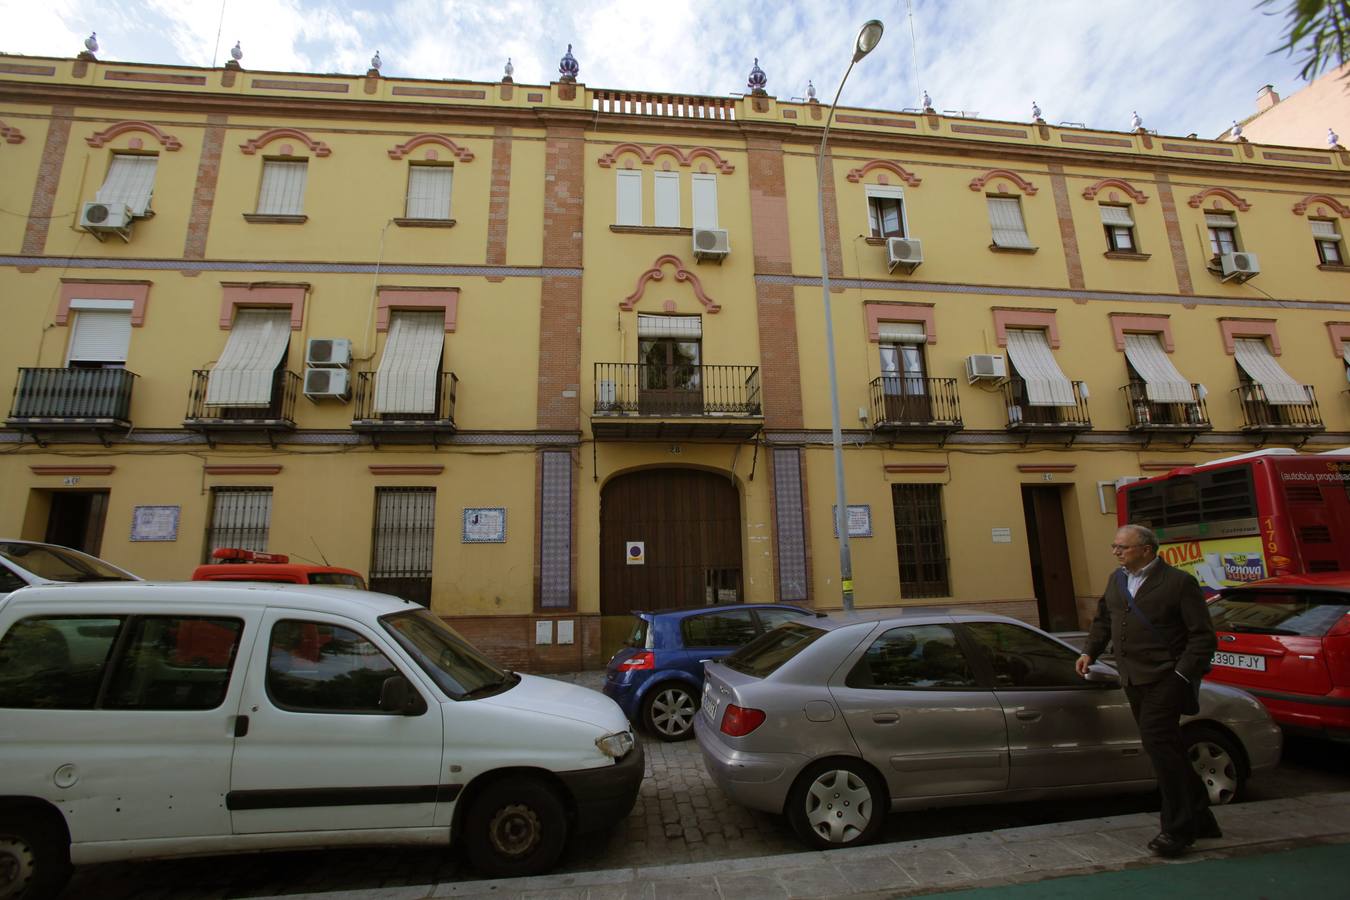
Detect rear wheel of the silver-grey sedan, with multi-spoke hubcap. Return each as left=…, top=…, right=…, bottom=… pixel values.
left=787, top=761, right=890, bottom=850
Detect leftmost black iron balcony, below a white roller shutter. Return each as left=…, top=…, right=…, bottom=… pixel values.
left=5, top=368, right=136, bottom=447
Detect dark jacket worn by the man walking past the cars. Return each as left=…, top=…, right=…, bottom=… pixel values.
left=1083, top=560, right=1218, bottom=684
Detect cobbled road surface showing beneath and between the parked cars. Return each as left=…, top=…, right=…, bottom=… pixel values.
left=63, top=737, right=1350, bottom=900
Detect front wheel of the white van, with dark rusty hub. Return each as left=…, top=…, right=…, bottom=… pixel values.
left=464, top=777, right=567, bottom=877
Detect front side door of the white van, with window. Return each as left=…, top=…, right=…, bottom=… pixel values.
left=227, top=609, right=443, bottom=834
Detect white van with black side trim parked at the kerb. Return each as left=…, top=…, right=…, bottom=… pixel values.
left=0, top=582, right=643, bottom=900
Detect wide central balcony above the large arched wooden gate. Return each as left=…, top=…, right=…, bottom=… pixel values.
left=591, top=363, right=764, bottom=441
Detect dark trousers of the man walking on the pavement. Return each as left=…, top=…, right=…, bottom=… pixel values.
left=1125, top=675, right=1214, bottom=841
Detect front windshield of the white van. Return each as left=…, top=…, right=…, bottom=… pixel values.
left=379, top=610, right=520, bottom=700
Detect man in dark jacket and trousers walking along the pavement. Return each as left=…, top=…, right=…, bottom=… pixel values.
left=1077, top=525, right=1223, bottom=857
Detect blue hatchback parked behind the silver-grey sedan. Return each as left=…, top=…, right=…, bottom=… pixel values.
left=605, top=603, right=819, bottom=741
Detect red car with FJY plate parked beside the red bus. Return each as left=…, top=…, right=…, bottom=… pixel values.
left=1206, top=572, right=1350, bottom=741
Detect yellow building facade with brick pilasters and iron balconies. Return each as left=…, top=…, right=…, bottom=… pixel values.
left=0, top=50, right=1350, bottom=669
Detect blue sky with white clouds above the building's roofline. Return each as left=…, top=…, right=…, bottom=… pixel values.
left=0, top=0, right=1328, bottom=138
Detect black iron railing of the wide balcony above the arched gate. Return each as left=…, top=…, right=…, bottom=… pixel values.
left=595, top=363, right=763, bottom=418
